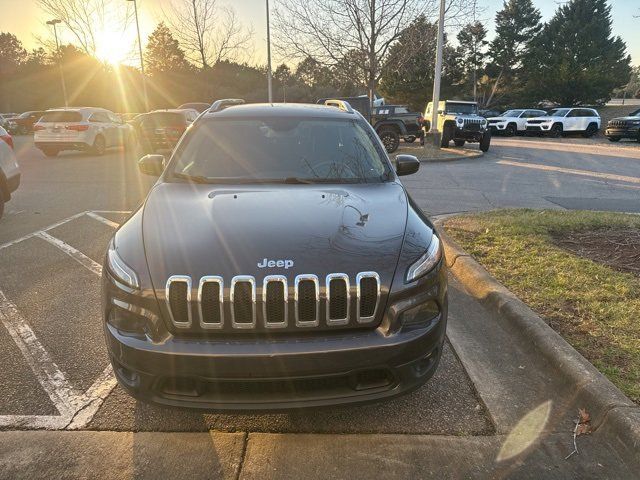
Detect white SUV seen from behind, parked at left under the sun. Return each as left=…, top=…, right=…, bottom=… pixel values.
left=33, top=107, right=134, bottom=157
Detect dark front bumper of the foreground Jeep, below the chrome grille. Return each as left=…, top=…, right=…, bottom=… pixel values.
left=103, top=267, right=447, bottom=411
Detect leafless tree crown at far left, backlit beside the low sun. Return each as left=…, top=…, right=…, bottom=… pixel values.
left=37, top=0, right=133, bottom=55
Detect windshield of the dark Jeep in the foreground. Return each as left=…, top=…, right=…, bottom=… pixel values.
left=173, top=118, right=389, bottom=183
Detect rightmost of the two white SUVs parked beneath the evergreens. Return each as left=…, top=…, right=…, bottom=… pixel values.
left=527, top=108, right=601, bottom=137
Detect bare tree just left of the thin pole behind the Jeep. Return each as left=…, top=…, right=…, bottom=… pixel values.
left=165, top=0, right=253, bottom=68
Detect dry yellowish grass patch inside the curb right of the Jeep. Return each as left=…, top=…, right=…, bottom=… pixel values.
left=445, top=210, right=640, bottom=404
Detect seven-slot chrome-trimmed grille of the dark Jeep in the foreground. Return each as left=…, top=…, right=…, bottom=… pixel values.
left=165, top=272, right=381, bottom=333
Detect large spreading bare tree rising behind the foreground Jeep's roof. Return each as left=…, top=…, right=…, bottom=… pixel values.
left=274, top=0, right=470, bottom=105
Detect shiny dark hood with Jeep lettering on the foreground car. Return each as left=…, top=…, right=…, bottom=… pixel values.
left=142, top=182, right=407, bottom=289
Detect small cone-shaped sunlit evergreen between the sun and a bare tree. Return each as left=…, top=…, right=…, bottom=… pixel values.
left=144, top=22, right=190, bottom=76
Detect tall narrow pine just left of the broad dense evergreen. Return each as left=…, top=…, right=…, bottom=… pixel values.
left=487, top=0, right=542, bottom=105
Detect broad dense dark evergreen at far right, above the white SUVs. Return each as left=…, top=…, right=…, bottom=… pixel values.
left=528, top=0, right=631, bottom=106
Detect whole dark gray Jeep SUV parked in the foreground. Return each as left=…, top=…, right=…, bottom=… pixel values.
left=102, top=101, right=447, bottom=411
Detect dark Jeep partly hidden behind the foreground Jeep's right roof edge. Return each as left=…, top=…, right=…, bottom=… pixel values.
left=318, top=97, right=424, bottom=153
